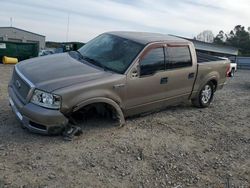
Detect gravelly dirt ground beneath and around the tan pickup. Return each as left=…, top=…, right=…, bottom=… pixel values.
left=0, top=65, right=250, bottom=188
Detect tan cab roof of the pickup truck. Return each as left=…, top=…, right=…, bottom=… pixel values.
left=107, top=31, right=190, bottom=45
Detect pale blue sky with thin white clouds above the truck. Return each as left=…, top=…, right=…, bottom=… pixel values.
left=0, top=0, right=250, bottom=42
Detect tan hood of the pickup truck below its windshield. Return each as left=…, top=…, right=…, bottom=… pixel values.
left=16, top=53, right=112, bottom=92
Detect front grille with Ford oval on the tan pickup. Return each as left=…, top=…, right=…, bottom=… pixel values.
left=12, top=69, right=30, bottom=100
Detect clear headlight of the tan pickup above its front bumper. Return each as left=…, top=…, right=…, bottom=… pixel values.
left=30, top=89, right=61, bottom=109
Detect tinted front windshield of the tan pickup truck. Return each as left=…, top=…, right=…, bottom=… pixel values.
left=78, top=34, right=143, bottom=74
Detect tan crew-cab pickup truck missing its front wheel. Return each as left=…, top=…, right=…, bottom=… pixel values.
left=8, top=32, right=230, bottom=134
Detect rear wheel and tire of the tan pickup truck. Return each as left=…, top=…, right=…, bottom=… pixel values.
left=192, top=82, right=215, bottom=108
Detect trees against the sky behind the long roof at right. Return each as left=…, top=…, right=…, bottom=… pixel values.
left=213, top=25, right=250, bottom=56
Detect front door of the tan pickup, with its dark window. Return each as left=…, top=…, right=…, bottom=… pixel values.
left=126, top=44, right=168, bottom=109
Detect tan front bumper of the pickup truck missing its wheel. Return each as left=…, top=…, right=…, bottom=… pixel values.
left=8, top=86, right=68, bottom=135
